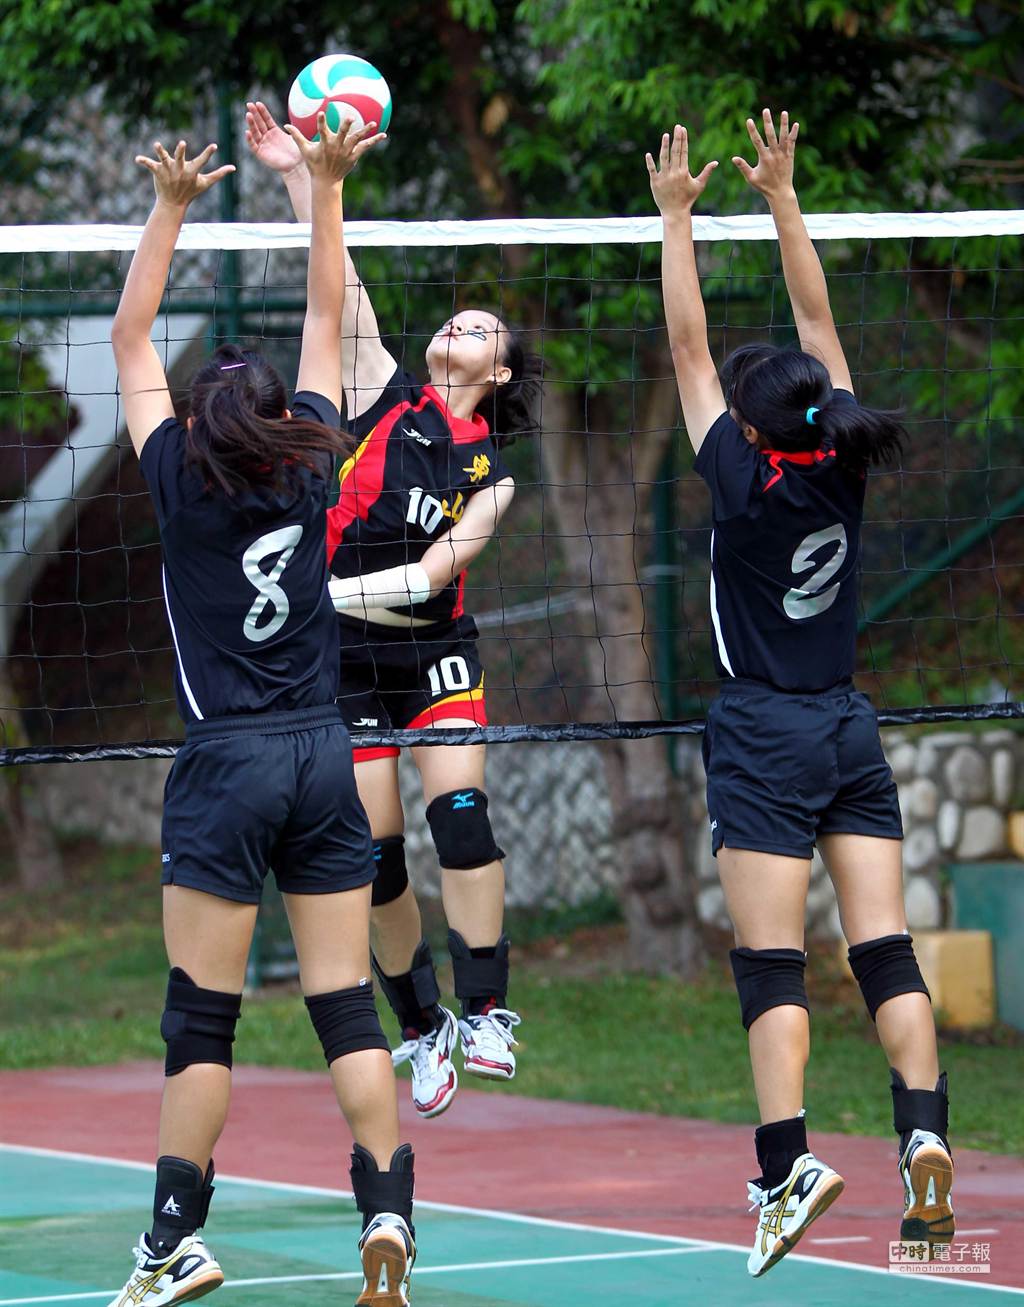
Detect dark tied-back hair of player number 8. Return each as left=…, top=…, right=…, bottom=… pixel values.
left=186, top=345, right=352, bottom=494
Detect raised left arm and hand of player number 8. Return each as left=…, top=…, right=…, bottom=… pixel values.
left=110, top=141, right=234, bottom=454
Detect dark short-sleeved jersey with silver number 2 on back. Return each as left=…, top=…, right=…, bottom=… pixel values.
left=696, top=391, right=866, bottom=693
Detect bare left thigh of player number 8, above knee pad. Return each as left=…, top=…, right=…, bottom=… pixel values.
left=163, top=885, right=258, bottom=993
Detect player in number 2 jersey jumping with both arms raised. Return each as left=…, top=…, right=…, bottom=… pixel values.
left=647, top=110, right=953, bottom=1276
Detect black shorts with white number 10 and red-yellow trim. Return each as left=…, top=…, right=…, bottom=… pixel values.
left=337, top=616, right=486, bottom=762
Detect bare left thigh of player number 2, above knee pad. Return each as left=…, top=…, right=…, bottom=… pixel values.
left=718, top=848, right=811, bottom=949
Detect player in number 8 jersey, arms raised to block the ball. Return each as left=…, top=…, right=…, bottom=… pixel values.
left=111, top=118, right=415, bottom=1307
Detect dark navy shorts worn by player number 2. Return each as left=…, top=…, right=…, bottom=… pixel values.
left=704, top=680, right=904, bottom=857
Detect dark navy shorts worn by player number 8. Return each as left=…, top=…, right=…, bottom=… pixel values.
left=161, top=706, right=375, bottom=903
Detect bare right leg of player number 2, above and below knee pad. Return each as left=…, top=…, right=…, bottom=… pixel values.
left=820, top=835, right=939, bottom=1089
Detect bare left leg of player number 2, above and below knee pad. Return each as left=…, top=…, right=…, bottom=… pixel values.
left=717, top=848, right=811, bottom=1123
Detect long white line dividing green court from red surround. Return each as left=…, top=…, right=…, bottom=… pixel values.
left=0, top=1144, right=1024, bottom=1307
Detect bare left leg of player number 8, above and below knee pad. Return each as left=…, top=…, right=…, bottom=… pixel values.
left=158, top=885, right=256, bottom=1171
